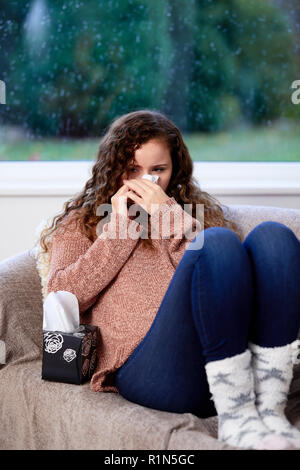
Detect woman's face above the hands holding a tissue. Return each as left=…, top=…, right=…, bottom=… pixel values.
left=122, top=139, right=172, bottom=192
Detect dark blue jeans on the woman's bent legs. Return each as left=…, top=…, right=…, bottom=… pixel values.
left=115, top=221, right=300, bottom=418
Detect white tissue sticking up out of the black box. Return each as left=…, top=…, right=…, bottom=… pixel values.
left=43, top=290, right=79, bottom=333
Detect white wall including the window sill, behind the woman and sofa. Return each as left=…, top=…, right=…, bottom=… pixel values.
left=0, top=162, right=300, bottom=261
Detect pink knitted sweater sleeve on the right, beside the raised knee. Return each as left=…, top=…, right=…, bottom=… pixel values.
left=151, top=197, right=203, bottom=268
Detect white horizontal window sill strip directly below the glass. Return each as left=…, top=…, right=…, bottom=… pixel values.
left=0, top=160, right=300, bottom=200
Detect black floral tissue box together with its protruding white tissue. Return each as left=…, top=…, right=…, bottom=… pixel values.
left=42, top=291, right=98, bottom=384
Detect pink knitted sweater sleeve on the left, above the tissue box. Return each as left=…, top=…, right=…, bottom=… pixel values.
left=47, top=212, right=141, bottom=313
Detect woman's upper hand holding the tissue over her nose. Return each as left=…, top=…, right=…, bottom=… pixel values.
left=123, top=179, right=169, bottom=215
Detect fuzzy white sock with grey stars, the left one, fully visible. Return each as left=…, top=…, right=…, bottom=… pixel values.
left=205, top=349, right=291, bottom=450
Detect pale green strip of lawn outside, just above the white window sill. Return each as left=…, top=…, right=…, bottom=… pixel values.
left=0, top=123, right=300, bottom=162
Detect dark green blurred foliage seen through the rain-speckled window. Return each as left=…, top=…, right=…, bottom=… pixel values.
left=0, top=0, right=300, bottom=137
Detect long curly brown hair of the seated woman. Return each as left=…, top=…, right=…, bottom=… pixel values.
left=39, top=109, right=240, bottom=253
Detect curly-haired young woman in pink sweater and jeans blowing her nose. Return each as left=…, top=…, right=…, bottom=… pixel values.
left=40, top=110, right=300, bottom=449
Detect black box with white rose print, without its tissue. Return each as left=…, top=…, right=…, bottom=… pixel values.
left=42, top=325, right=98, bottom=385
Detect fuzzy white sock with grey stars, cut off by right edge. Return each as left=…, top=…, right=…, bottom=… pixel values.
left=249, top=340, right=300, bottom=448
